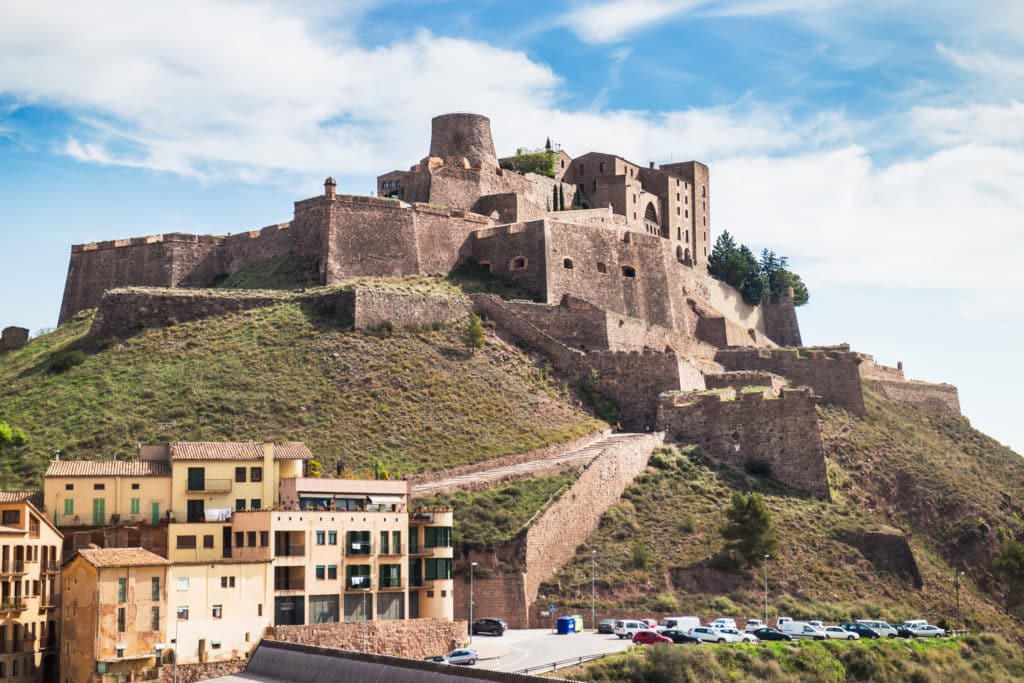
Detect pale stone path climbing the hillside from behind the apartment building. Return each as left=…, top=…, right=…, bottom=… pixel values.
left=413, top=433, right=645, bottom=497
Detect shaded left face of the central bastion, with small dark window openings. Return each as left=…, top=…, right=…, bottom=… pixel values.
left=470, top=220, right=548, bottom=301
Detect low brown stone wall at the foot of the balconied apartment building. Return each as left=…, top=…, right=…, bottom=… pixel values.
left=268, top=618, right=468, bottom=659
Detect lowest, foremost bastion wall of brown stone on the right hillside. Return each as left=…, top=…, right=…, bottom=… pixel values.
left=657, top=389, right=830, bottom=500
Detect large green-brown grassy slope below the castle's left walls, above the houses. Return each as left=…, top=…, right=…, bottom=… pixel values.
left=0, top=282, right=601, bottom=487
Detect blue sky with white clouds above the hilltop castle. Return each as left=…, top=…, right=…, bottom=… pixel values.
left=0, top=0, right=1024, bottom=452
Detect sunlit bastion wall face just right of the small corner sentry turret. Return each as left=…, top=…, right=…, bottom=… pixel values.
left=321, top=196, right=420, bottom=285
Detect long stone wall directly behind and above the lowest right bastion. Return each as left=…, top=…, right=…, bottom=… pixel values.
left=715, top=348, right=864, bottom=415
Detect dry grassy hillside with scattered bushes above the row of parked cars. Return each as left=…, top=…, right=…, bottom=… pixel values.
left=541, top=397, right=1024, bottom=639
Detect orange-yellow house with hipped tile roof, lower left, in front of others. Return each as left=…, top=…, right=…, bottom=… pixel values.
left=60, top=548, right=170, bottom=683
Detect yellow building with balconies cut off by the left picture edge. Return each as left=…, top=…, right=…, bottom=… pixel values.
left=0, top=492, right=62, bottom=681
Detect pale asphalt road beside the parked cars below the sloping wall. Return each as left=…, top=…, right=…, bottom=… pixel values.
left=473, top=629, right=633, bottom=672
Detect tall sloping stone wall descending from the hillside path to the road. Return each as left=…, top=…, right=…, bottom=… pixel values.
left=455, top=433, right=664, bottom=629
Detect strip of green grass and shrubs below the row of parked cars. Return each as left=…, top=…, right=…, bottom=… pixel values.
left=565, top=636, right=1024, bottom=683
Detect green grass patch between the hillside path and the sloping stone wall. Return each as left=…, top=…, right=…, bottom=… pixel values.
left=416, top=469, right=579, bottom=551
